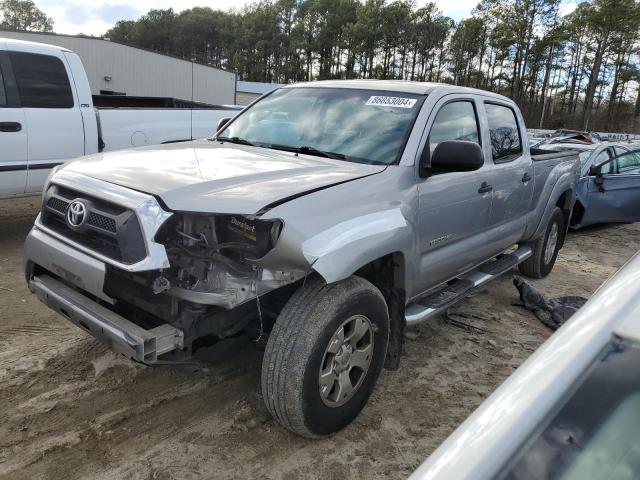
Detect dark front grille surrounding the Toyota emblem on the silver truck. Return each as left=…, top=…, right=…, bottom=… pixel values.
left=41, top=185, right=146, bottom=264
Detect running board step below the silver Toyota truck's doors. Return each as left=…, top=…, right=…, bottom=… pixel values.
left=405, top=246, right=532, bottom=326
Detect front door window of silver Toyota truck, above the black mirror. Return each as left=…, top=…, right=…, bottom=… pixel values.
left=428, top=100, right=480, bottom=158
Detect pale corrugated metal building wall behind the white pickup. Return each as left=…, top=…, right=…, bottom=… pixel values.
left=0, top=31, right=236, bottom=104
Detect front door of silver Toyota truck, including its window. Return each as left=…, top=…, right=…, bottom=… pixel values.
left=416, top=95, right=492, bottom=291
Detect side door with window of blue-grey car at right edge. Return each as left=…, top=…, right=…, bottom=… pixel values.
left=582, top=149, right=640, bottom=225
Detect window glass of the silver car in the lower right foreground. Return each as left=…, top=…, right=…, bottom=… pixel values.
left=498, top=339, right=640, bottom=480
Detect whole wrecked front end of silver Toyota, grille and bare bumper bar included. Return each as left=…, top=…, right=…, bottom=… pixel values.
left=25, top=172, right=310, bottom=363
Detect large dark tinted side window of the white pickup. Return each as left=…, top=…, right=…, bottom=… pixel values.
left=9, top=52, right=73, bottom=108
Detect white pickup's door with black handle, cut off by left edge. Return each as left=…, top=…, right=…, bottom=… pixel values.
left=0, top=43, right=28, bottom=197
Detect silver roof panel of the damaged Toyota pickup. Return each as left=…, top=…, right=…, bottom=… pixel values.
left=284, top=80, right=511, bottom=101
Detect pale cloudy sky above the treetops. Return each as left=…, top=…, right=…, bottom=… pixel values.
left=35, top=0, right=478, bottom=35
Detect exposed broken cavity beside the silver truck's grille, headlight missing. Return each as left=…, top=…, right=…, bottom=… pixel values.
left=99, top=213, right=306, bottom=358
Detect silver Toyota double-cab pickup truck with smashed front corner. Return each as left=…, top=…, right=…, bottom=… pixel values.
left=25, top=81, right=579, bottom=438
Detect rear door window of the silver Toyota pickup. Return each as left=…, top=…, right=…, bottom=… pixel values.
left=485, top=103, right=522, bottom=163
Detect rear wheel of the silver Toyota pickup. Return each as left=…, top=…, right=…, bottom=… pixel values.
left=518, top=207, right=566, bottom=278
